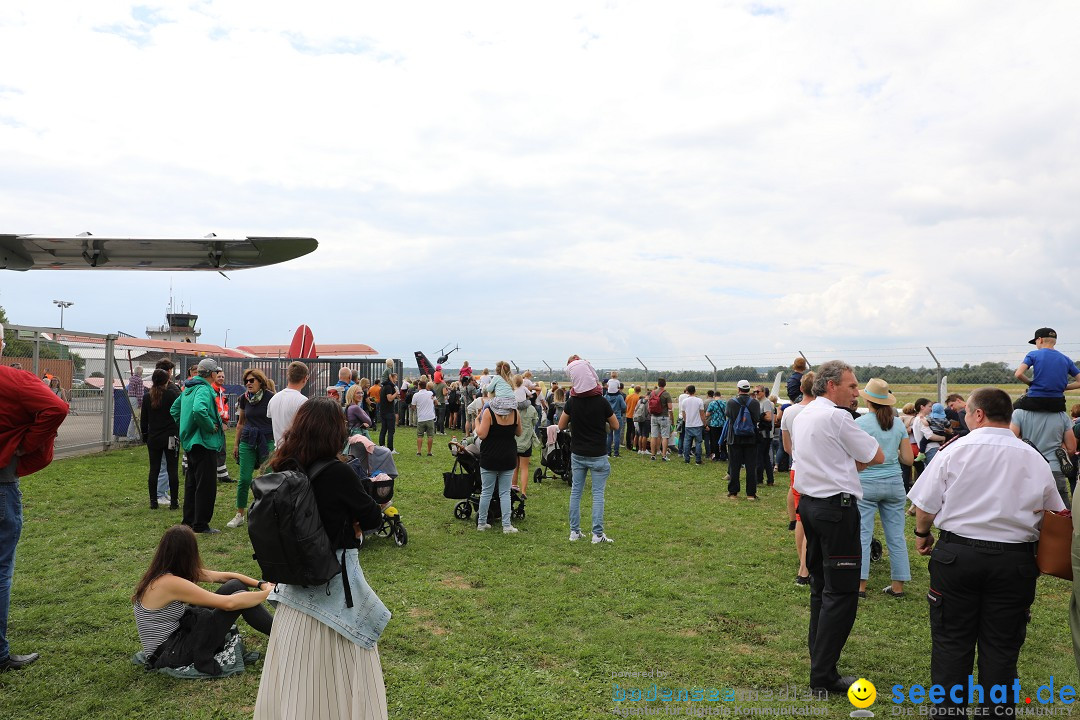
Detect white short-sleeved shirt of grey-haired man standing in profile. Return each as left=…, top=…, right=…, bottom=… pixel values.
left=781, top=397, right=878, bottom=499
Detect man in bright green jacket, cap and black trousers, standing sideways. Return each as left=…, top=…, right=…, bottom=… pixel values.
left=171, top=357, right=225, bottom=533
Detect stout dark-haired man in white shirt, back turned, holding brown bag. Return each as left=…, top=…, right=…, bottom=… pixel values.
left=911, top=388, right=1065, bottom=717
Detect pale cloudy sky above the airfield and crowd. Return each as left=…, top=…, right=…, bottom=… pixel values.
left=0, top=0, right=1080, bottom=369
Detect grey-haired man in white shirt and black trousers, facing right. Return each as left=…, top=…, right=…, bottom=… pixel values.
left=792, top=361, right=885, bottom=694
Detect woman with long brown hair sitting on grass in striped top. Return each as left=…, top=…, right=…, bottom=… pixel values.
left=132, top=525, right=273, bottom=675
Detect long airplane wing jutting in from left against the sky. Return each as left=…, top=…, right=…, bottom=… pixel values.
left=0, top=233, right=319, bottom=271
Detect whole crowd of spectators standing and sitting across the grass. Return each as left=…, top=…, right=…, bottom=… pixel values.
left=0, top=321, right=1080, bottom=718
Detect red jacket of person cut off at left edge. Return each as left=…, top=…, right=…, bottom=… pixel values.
left=0, top=365, right=68, bottom=477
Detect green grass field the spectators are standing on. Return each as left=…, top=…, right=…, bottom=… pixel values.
left=0, top=430, right=1076, bottom=720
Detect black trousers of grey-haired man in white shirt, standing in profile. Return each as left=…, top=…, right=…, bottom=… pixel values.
left=798, top=495, right=863, bottom=688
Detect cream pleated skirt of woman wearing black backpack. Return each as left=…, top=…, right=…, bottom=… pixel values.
left=255, top=604, right=387, bottom=720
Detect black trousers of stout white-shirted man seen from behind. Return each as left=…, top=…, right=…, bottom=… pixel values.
left=927, top=532, right=1039, bottom=718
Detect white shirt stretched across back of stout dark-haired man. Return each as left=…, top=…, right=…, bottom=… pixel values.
left=907, top=427, right=1065, bottom=543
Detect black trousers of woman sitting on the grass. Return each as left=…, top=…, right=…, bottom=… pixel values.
left=153, top=580, right=273, bottom=675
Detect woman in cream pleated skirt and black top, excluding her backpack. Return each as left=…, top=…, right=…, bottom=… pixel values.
left=252, top=397, right=390, bottom=720
